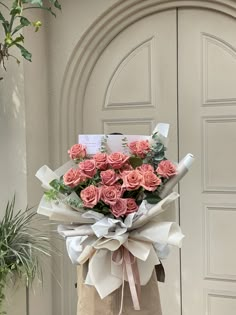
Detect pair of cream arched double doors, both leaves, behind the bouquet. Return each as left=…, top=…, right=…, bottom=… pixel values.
left=54, top=5, right=236, bottom=315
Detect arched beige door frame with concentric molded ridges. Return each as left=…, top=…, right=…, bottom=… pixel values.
left=55, top=0, right=236, bottom=312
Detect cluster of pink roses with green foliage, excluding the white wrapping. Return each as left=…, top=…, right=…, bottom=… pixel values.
left=45, top=136, right=176, bottom=218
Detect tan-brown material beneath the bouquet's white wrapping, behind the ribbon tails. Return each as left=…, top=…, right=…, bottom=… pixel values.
left=77, top=264, right=162, bottom=315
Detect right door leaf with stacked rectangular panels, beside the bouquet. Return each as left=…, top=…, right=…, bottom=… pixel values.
left=178, top=9, right=236, bottom=315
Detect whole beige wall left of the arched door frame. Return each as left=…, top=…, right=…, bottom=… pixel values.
left=0, top=0, right=116, bottom=315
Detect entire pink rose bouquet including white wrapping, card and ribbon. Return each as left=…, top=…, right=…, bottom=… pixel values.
left=36, top=124, right=194, bottom=315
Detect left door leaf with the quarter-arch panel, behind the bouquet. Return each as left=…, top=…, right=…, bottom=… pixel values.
left=83, top=10, right=180, bottom=315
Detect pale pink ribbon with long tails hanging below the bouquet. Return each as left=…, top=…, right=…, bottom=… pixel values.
left=112, top=246, right=141, bottom=315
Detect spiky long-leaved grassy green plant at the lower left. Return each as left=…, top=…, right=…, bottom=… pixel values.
left=0, top=198, right=52, bottom=315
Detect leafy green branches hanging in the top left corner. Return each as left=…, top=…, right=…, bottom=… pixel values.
left=0, top=0, right=61, bottom=79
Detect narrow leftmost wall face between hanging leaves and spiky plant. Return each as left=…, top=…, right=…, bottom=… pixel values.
left=0, top=8, right=27, bottom=315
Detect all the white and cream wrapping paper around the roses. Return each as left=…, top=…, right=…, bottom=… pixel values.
left=36, top=124, right=193, bottom=306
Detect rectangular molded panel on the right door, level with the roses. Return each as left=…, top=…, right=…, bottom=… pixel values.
left=201, top=115, right=236, bottom=194
